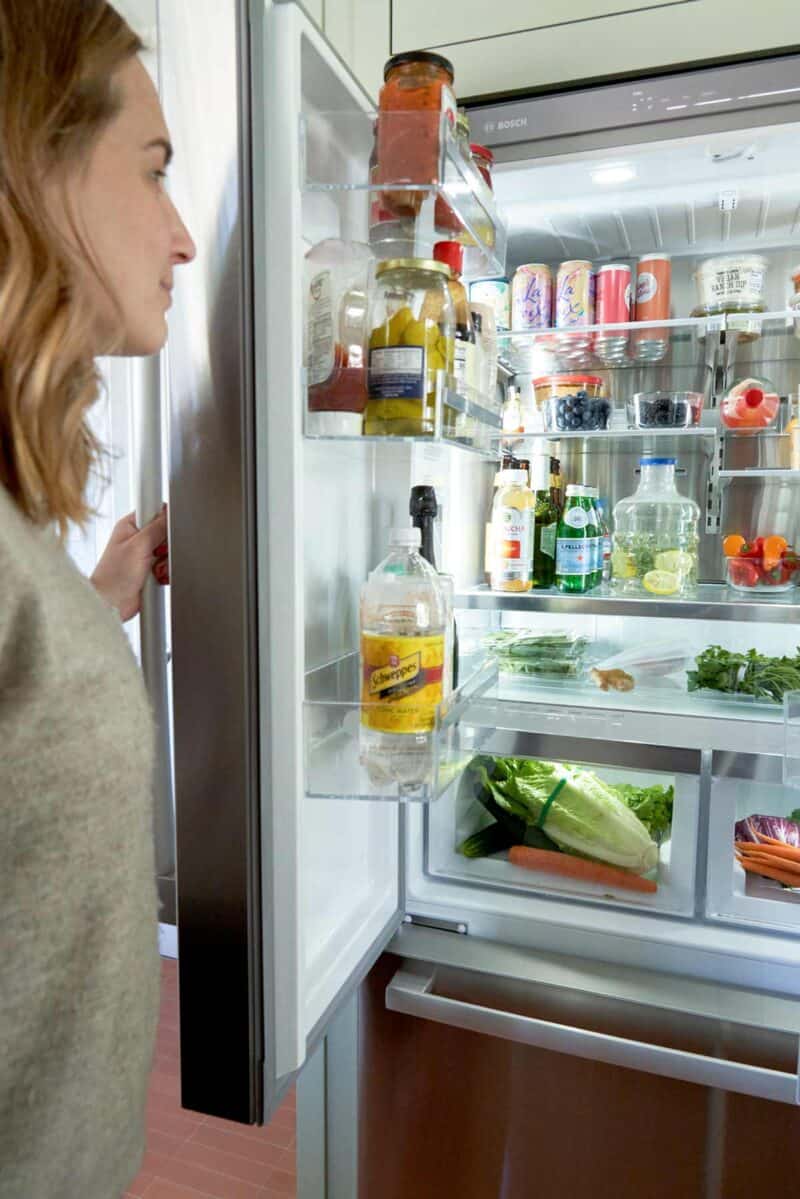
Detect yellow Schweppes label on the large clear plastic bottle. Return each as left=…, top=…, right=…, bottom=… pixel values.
left=361, top=633, right=445, bottom=733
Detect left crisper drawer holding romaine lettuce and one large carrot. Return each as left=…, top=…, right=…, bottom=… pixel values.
left=425, top=704, right=700, bottom=917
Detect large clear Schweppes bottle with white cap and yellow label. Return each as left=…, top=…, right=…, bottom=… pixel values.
left=361, top=529, right=452, bottom=799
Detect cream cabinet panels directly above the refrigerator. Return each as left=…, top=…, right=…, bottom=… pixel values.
left=388, top=0, right=800, bottom=98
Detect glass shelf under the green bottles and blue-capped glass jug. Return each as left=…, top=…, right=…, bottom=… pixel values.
left=455, top=583, right=800, bottom=625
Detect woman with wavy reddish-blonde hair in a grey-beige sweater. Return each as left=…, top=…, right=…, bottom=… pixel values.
left=0, top=0, right=194, bottom=1199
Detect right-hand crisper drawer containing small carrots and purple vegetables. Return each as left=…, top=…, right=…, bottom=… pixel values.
left=706, top=753, right=800, bottom=929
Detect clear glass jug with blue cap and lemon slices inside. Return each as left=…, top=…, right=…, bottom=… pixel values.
left=612, top=457, right=700, bottom=596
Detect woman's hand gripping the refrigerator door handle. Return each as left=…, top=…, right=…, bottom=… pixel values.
left=91, top=505, right=169, bottom=620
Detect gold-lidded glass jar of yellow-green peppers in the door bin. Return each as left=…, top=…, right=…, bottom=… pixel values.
left=363, top=258, right=456, bottom=436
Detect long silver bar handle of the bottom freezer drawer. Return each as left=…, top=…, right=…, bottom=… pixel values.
left=386, top=969, right=800, bottom=1104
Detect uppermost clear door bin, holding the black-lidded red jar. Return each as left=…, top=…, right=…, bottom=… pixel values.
left=300, top=112, right=506, bottom=275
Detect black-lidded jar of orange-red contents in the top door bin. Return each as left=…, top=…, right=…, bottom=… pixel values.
left=377, top=50, right=457, bottom=217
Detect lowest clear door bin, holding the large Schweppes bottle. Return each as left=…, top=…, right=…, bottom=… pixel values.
left=303, top=653, right=498, bottom=803
